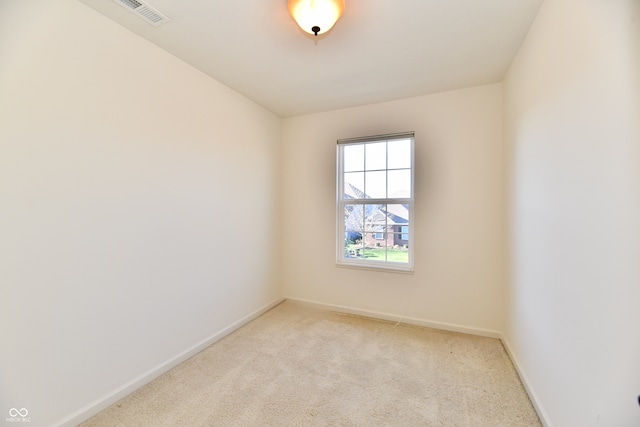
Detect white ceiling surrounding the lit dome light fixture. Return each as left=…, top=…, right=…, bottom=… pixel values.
left=80, top=0, right=542, bottom=117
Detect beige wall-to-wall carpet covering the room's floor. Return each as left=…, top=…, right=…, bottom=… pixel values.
left=82, top=301, right=541, bottom=427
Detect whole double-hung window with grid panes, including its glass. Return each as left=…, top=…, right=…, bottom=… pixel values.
left=337, top=132, right=414, bottom=271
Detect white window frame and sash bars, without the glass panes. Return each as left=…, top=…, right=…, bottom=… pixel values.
left=336, top=132, right=415, bottom=273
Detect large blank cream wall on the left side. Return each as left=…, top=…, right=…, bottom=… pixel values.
left=0, top=0, right=281, bottom=426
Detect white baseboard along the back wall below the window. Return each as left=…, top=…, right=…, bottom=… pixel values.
left=286, top=297, right=502, bottom=339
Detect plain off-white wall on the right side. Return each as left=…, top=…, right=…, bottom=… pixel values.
left=504, top=0, right=640, bottom=427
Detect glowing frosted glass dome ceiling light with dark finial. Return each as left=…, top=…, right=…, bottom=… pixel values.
left=289, top=0, right=344, bottom=36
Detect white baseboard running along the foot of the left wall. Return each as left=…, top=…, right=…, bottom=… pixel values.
left=53, top=298, right=284, bottom=427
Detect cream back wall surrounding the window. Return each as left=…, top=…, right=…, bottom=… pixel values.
left=282, top=84, right=504, bottom=331
